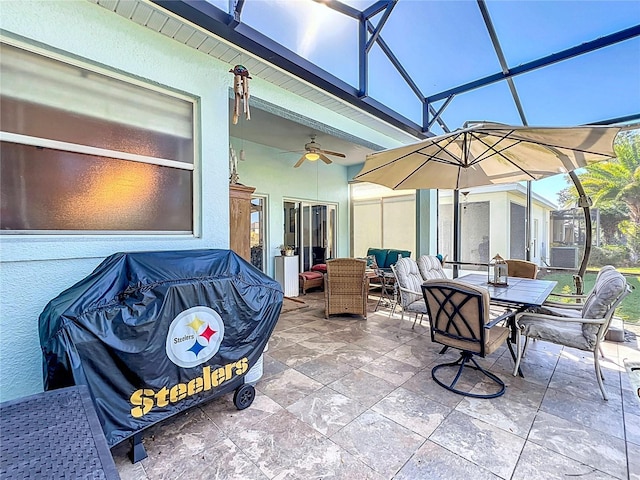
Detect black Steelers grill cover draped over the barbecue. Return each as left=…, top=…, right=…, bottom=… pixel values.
left=39, top=250, right=283, bottom=446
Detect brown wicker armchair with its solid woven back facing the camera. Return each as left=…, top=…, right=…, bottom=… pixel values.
left=324, top=258, right=369, bottom=319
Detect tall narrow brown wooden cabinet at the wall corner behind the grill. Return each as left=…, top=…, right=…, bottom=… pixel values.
left=229, top=184, right=255, bottom=262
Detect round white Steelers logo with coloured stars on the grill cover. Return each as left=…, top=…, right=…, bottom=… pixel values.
left=166, top=306, right=224, bottom=368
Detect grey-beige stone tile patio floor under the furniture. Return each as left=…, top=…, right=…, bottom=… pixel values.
left=112, top=292, right=640, bottom=480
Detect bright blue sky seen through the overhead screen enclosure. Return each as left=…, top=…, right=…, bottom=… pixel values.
left=216, top=0, right=640, bottom=134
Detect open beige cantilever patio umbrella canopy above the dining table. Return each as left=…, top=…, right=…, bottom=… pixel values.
left=354, top=122, right=620, bottom=190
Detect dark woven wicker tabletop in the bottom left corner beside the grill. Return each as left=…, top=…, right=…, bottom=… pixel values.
left=0, top=385, right=120, bottom=479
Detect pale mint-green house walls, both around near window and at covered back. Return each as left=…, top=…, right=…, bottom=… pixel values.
left=0, top=0, right=408, bottom=401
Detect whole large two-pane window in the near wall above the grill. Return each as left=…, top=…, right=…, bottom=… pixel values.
left=0, top=43, right=195, bottom=234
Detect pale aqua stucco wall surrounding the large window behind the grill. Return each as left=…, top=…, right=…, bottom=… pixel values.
left=0, top=1, right=234, bottom=400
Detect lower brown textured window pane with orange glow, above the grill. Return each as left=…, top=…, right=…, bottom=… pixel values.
left=0, top=142, right=193, bottom=232
